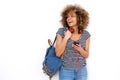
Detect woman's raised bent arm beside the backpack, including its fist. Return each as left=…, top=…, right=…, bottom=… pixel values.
left=55, top=31, right=71, bottom=57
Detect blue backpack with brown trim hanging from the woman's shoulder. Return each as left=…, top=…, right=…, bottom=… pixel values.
left=43, top=37, right=62, bottom=80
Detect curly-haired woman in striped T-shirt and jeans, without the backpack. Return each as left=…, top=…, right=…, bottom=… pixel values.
left=55, top=5, right=90, bottom=80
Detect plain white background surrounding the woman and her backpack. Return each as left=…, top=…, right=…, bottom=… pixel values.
left=0, top=0, right=120, bottom=80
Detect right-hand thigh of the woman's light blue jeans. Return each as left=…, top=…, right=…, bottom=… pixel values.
left=77, top=67, right=87, bottom=80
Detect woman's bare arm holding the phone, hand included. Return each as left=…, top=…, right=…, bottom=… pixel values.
left=73, top=38, right=90, bottom=58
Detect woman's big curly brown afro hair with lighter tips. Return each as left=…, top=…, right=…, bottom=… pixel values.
left=61, top=4, right=89, bottom=29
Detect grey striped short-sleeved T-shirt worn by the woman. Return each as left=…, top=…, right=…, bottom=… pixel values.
left=56, top=28, right=90, bottom=69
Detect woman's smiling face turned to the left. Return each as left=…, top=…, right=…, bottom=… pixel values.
left=66, top=11, right=77, bottom=27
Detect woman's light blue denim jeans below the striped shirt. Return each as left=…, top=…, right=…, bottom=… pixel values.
left=59, top=66, right=87, bottom=80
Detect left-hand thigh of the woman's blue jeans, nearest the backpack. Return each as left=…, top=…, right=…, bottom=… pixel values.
left=59, top=68, right=74, bottom=80
